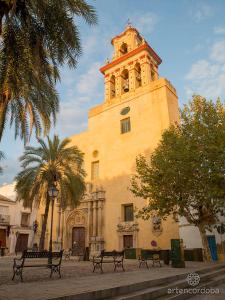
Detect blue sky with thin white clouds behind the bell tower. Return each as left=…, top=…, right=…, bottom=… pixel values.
left=0, top=0, right=225, bottom=184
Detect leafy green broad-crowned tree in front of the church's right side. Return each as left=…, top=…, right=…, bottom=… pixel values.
left=131, top=95, right=225, bottom=259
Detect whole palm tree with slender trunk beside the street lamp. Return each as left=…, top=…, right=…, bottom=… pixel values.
left=16, top=135, right=85, bottom=250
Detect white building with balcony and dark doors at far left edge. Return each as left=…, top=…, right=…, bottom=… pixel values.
left=0, top=183, right=37, bottom=254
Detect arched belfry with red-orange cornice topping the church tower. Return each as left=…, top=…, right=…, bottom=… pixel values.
left=100, top=25, right=162, bottom=104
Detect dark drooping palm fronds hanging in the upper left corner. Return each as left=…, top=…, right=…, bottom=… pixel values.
left=0, top=0, right=97, bottom=142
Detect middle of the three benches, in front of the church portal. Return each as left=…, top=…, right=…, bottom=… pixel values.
left=93, top=250, right=125, bottom=273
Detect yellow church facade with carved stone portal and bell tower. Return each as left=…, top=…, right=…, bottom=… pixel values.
left=35, top=26, right=179, bottom=254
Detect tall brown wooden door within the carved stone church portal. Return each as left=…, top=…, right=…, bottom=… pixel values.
left=72, top=227, right=85, bottom=255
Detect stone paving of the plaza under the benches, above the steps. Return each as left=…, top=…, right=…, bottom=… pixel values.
left=0, top=257, right=224, bottom=300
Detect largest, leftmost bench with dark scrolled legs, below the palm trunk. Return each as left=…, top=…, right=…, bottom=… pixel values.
left=12, top=250, right=63, bottom=282
